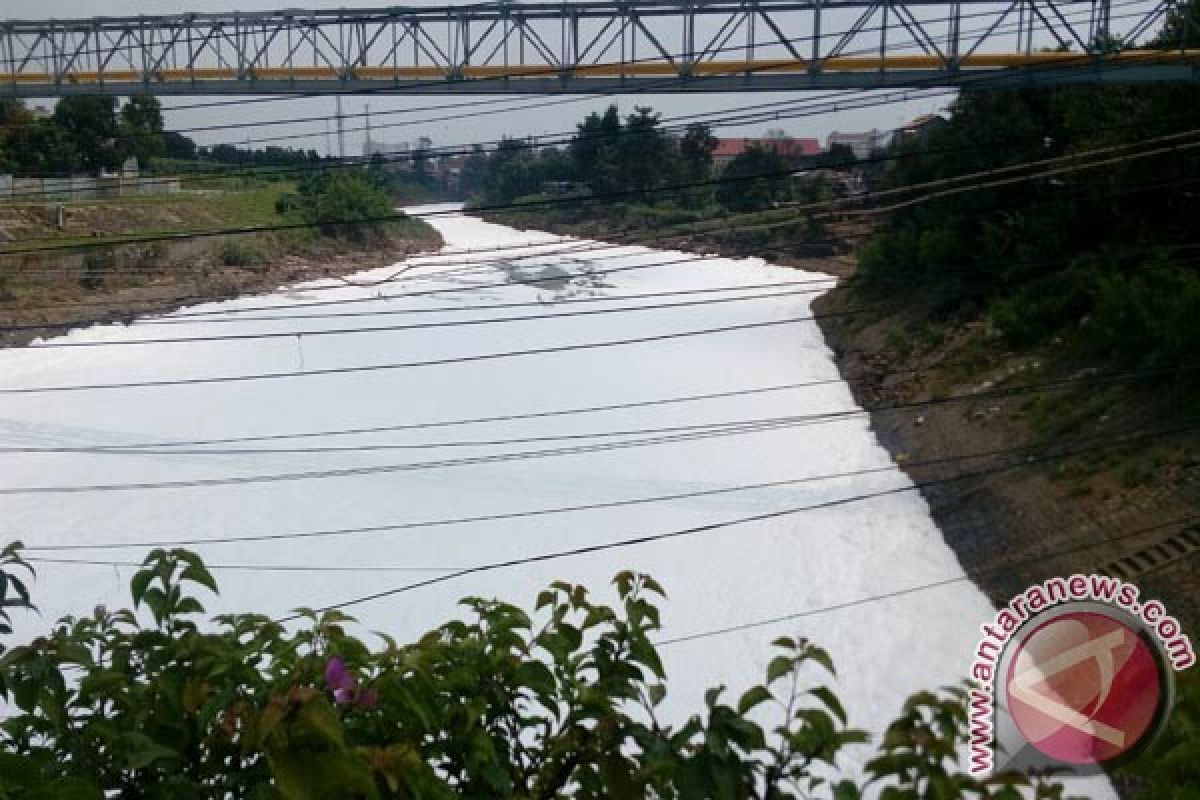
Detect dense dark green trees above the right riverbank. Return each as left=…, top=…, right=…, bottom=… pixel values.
left=860, top=6, right=1200, bottom=384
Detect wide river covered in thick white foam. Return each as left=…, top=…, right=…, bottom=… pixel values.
left=0, top=206, right=1084, bottom=782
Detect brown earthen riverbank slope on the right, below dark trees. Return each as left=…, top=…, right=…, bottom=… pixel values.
left=814, top=287, right=1200, bottom=631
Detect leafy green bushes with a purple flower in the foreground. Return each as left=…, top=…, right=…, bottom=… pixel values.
left=0, top=545, right=1099, bottom=800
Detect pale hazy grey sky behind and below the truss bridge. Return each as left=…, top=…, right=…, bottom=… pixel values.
left=0, top=0, right=1051, bottom=155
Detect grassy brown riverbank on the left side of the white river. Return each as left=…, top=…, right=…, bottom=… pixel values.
left=0, top=191, right=442, bottom=347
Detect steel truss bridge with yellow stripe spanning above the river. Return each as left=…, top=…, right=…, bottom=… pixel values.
left=0, top=0, right=1200, bottom=97
